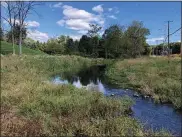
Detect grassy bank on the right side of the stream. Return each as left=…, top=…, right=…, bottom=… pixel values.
left=106, top=57, right=182, bottom=109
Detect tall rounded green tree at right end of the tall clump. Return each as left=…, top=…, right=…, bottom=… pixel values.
left=125, top=21, right=150, bottom=57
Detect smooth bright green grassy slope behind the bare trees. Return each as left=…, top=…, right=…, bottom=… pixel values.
left=1, top=41, right=45, bottom=55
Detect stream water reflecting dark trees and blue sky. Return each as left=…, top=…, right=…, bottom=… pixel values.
left=53, top=65, right=182, bottom=136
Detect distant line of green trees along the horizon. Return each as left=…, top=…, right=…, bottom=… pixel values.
left=0, top=21, right=180, bottom=58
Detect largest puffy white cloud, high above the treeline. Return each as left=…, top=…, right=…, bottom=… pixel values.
left=57, top=5, right=105, bottom=33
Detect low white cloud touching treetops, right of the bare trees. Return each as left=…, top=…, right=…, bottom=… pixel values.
left=27, top=30, right=49, bottom=42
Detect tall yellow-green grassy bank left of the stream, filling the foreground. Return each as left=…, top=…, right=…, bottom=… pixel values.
left=1, top=55, right=169, bottom=136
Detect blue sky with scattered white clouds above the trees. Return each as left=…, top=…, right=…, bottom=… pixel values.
left=1, top=2, right=181, bottom=45
